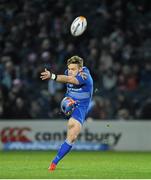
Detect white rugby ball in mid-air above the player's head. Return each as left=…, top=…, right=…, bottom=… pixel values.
left=70, top=16, right=87, bottom=36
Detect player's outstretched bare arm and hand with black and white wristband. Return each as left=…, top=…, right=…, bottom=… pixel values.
left=40, top=68, right=79, bottom=85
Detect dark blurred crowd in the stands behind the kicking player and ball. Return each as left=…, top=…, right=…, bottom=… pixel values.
left=0, top=0, right=151, bottom=120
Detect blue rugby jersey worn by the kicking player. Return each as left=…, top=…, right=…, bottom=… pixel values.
left=65, top=66, right=93, bottom=106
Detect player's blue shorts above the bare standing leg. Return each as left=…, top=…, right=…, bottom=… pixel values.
left=70, top=105, right=88, bottom=125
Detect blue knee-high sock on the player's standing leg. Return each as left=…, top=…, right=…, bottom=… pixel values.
left=52, top=140, right=72, bottom=164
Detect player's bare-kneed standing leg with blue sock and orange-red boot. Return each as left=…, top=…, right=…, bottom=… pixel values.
left=49, top=118, right=82, bottom=171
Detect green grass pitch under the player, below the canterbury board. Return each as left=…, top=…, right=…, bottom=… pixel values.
left=0, top=151, right=151, bottom=179
